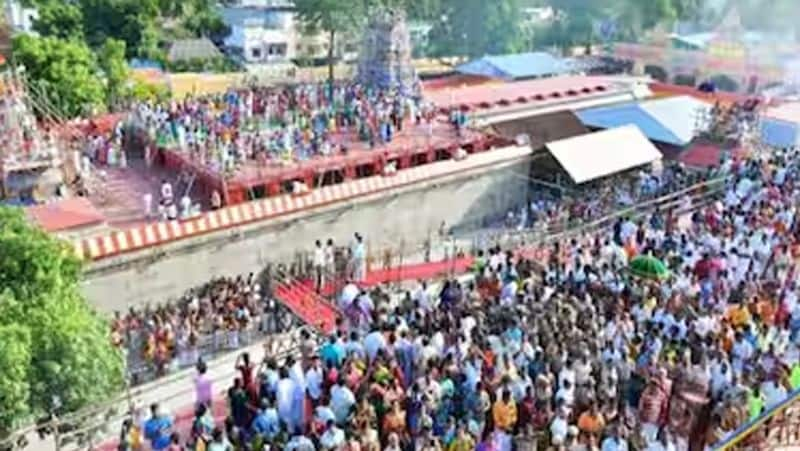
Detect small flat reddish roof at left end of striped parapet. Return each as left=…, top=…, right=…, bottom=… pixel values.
left=26, top=197, right=105, bottom=232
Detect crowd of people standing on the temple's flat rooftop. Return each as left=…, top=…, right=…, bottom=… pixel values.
left=135, top=83, right=444, bottom=172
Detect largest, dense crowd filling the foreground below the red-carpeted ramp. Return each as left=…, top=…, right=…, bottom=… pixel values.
left=120, top=147, right=800, bottom=451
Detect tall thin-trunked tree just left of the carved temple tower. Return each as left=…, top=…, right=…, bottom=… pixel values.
left=294, top=0, right=365, bottom=82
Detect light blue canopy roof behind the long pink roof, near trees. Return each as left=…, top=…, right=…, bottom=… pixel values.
left=456, top=52, right=571, bottom=80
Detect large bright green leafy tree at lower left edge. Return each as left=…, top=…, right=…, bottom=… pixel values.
left=0, top=207, right=124, bottom=434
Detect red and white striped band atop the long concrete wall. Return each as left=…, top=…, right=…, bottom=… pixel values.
left=74, top=147, right=531, bottom=261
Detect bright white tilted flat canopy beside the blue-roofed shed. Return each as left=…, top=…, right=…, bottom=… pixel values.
left=547, top=125, right=661, bottom=184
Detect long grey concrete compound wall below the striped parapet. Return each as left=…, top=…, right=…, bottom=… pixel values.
left=83, top=156, right=531, bottom=313
